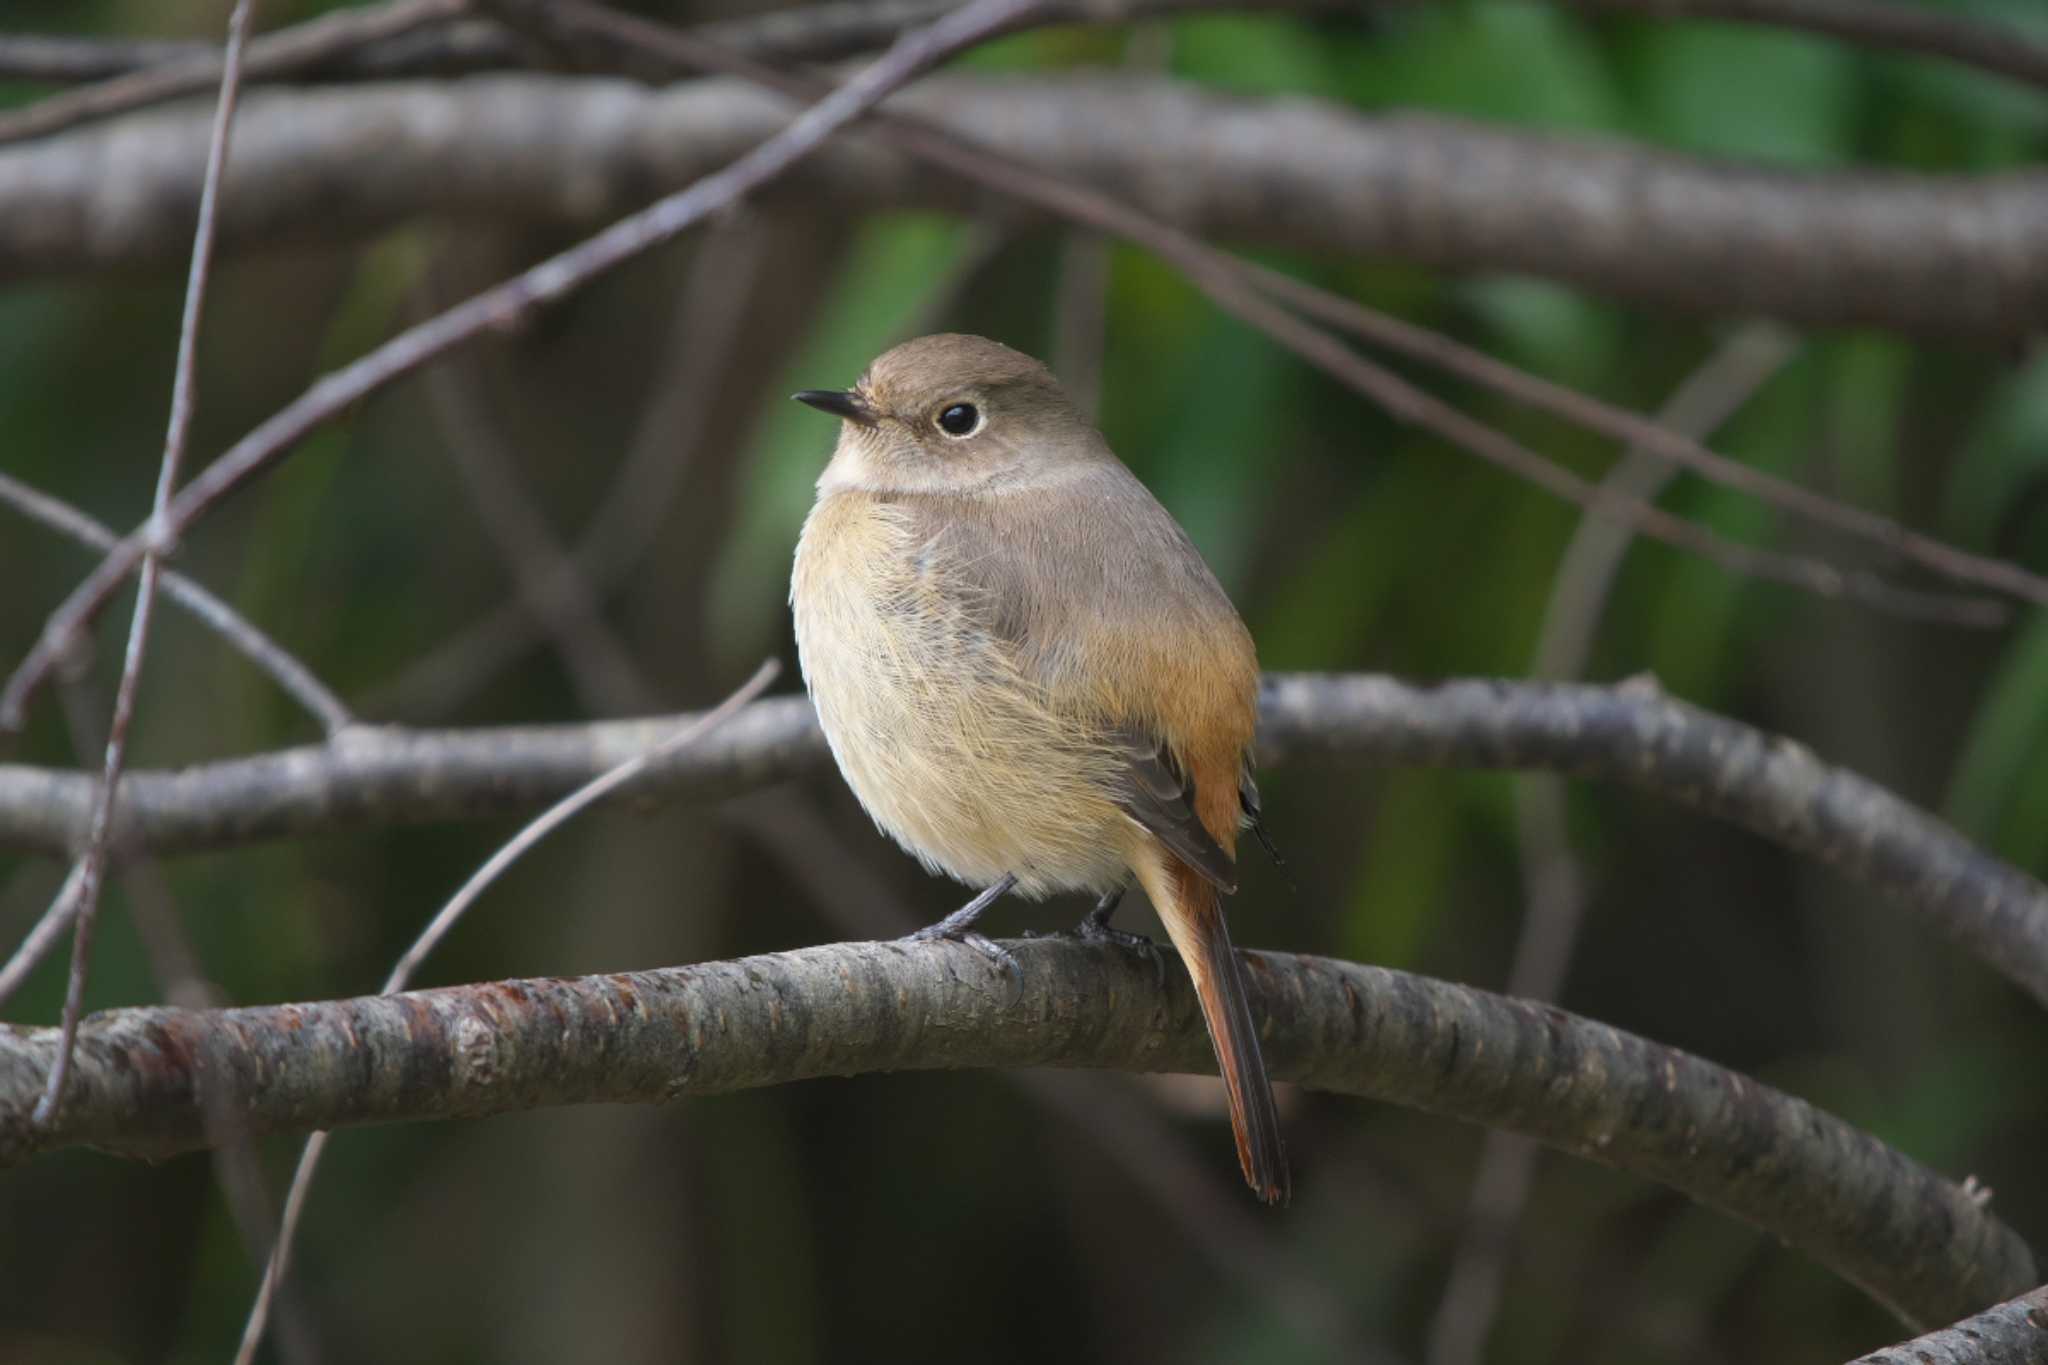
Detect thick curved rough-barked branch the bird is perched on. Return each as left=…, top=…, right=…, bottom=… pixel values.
left=0, top=939, right=2036, bottom=1322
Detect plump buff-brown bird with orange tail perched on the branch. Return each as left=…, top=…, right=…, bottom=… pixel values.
left=791, top=334, right=1288, bottom=1203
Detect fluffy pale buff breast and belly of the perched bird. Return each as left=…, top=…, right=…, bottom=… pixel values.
left=791, top=493, right=1137, bottom=896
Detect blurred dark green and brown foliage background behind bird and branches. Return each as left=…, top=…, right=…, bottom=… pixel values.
left=0, top=0, right=2048, bottom=1365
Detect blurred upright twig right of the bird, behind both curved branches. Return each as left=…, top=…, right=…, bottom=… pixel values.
left=1423, top=323, right=1796, bottom=1365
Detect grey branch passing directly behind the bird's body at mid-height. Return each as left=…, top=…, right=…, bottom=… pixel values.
left=12, top=673, right=2048, bottom=1003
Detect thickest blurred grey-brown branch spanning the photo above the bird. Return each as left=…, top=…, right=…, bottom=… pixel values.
left=0, top=76, right=2048, bottom=340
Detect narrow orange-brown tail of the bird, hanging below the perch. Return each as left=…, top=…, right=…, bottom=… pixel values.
left=1139, top=851, right=1288, bottom=1203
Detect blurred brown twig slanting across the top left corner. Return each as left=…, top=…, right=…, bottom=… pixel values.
left=0, top=0, right=467, bottom=143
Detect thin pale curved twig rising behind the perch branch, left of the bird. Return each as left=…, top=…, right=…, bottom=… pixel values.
left=236, top=659, right=780, bottom=1365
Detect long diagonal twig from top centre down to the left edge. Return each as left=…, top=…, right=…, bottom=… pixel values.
left=0, top=0, right=1038, bottom=733
